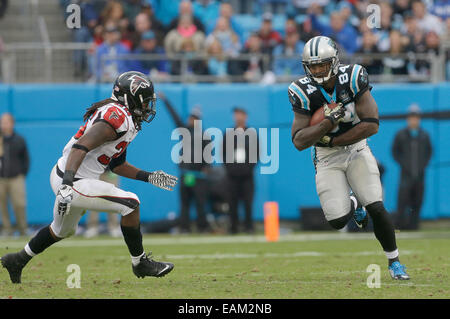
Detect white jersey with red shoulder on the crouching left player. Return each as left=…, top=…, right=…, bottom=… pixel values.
left=58, top=102, right=138, bottom=179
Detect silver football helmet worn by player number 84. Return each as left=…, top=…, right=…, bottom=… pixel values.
left=302, top=36, right=339, bottom=84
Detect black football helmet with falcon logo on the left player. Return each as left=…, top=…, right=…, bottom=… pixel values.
left=112, top=71, right=156, bottom=130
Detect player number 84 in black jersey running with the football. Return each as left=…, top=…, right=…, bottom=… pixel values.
left=288, top=36, right=409, bottom=280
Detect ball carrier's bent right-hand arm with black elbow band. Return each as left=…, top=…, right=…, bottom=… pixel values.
left=333, top=90, right=379, bottom=146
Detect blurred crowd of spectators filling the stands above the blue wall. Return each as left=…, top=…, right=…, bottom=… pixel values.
left=55, top=0, right=450, bottom=81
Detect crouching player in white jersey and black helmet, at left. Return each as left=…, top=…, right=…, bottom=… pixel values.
left=1, top=71, right=177, bottom=283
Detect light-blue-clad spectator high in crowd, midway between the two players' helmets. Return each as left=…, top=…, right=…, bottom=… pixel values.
left=206, top=17, right=241, bottom=57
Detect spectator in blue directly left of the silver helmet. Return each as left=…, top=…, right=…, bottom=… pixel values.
left=272, top=27, right=305, bottom=76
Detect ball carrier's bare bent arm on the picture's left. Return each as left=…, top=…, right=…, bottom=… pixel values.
left=291, top=112, right=333, bottom=151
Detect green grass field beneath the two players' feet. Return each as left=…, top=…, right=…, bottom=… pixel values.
left=0, top=231, right=450, bottom=299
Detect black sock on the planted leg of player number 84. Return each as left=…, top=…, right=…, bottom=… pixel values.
left=366, top=202, right=398, bottom=262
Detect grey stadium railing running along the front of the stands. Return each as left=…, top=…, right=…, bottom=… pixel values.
left=0, top=41, right=450, bottom=83
